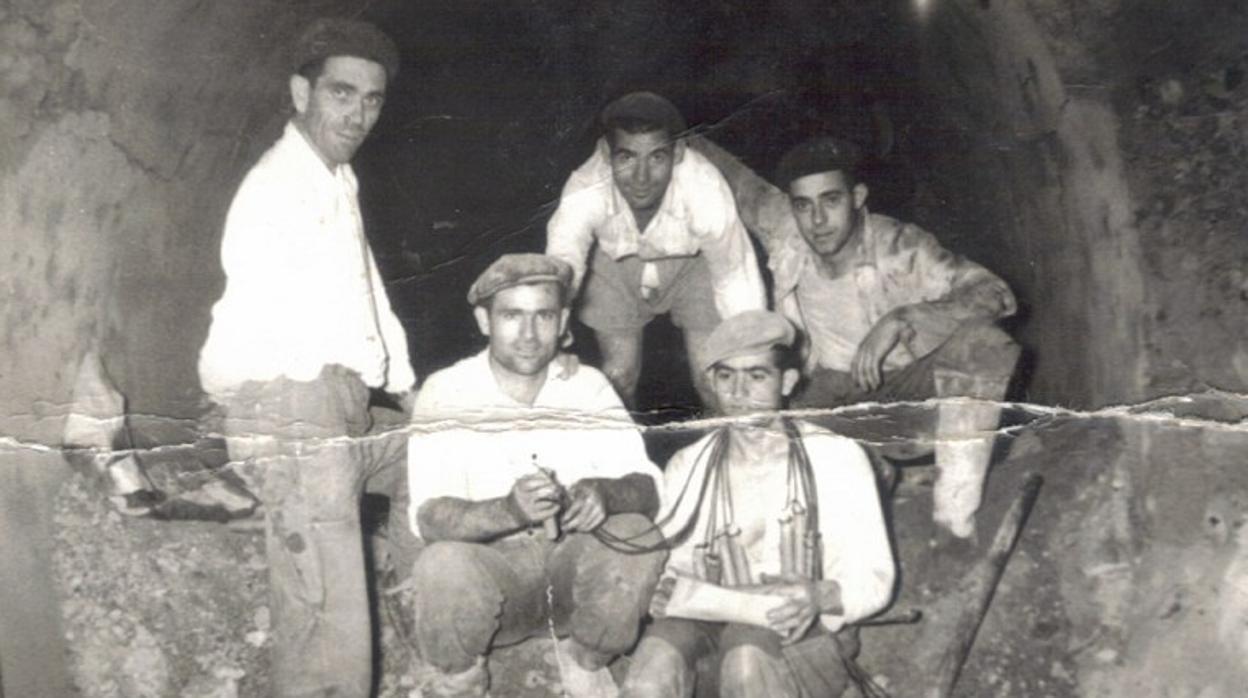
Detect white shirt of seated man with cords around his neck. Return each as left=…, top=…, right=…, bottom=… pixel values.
left=660, top=422, right=896, bottom=632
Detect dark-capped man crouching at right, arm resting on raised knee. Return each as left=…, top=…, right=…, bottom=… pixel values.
left=768, top=137, right=1018, bottom=537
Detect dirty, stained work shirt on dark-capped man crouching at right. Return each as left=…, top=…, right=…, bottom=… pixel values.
left=768, top=212, right=1016, bottom=371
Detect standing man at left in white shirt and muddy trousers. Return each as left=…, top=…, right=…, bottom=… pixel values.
left=200, top=19, right=416, bottom=697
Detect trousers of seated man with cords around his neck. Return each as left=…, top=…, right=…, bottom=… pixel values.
left=622, top=618, right=857, bottom=698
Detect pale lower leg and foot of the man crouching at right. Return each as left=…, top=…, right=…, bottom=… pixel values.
left=932, top=370, right=1005, bottom=538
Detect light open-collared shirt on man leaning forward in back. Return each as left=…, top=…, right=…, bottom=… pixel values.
left=545, top=139, right=766, bottom=317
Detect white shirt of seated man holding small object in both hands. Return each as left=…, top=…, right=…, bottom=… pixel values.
left=407, top=348, right=663, bottom=537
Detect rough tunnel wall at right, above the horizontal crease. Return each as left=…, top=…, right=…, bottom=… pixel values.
left=911, top=0, right=1248, bottom=407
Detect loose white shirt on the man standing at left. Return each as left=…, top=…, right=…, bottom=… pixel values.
left=200, top=122, right=416, bottom=395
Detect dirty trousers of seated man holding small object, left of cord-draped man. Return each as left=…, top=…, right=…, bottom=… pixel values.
left=412, top=513, right=668, bottom=674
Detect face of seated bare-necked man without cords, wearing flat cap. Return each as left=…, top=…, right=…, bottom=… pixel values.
left=473, top=282, right=568, bottom=376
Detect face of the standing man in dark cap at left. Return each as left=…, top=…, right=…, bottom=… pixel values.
left=291, top=56, right=386, bottom=167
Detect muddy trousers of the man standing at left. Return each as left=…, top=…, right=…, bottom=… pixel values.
left=222, top=367, right=407, bottom=698
